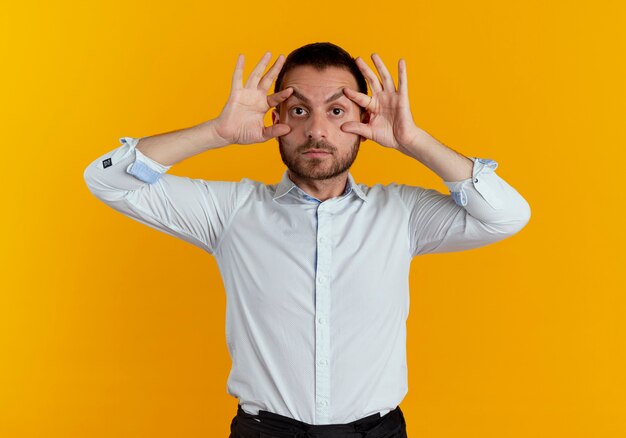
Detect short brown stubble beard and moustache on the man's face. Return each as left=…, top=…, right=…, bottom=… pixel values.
left=277, top=136, right=361, bottom=180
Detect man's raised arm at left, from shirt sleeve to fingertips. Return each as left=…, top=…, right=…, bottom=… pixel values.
left=84, top=52, right=292, bottom=253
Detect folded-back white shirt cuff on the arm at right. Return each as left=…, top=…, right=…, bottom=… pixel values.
left=443, top=157, right=502, bottom=210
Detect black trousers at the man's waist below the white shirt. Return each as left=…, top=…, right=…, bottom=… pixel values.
left=229, top=405, right=407, bottom=438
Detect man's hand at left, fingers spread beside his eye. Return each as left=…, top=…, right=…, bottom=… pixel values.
left=213, top=52, right=293, bottom=144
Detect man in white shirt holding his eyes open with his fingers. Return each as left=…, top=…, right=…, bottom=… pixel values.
left=84, top=43, right=530, bottom=438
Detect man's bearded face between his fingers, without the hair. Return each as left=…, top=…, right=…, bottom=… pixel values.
left=272, top=65, right=364, bottom=180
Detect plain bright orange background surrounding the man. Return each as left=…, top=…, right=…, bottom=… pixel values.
left=0, top=0, right=626, bottom=438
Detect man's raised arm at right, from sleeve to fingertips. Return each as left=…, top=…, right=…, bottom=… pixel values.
left=342, top=54, right=530, bottom=256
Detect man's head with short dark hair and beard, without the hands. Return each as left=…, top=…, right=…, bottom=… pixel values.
left=272, top=43, right=367, bottom=180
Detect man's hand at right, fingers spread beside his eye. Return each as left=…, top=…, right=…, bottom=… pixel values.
left=341, top=53, right=421, bottom=155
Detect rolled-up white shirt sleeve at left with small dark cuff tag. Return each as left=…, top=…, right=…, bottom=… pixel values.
left=83, top=137, right=253, bottom=254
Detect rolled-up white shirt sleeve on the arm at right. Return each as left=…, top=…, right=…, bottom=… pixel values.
left=400, top=157, right=530, bottom=256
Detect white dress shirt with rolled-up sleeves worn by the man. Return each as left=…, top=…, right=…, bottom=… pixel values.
left=84, top=137, right=530, bottom=425
